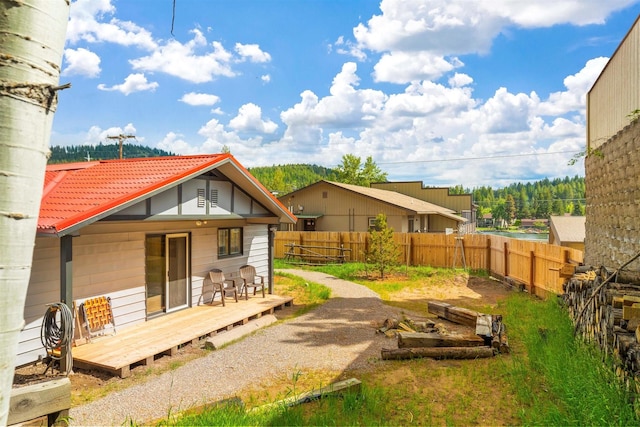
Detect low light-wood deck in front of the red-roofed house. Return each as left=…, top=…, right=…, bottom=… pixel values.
left=72, top=295, right=293, bottom=378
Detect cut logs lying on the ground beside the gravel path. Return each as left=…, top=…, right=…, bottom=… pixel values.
left=378, top=301, right=509, bottom=360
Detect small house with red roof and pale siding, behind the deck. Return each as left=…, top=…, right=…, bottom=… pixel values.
left=17, top=154, right=297, bottom=366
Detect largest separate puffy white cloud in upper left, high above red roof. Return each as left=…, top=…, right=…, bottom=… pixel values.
left=129, top=29, right=236, bottom=83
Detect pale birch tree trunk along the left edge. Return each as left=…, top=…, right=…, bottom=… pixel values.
left=0, top=0, right=70, bottom=425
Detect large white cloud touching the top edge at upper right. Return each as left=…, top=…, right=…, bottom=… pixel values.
left=348, top=0, right=637, bottom=83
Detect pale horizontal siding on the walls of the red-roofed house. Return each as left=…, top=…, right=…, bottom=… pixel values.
left=17, top=220, right=269, bottom=365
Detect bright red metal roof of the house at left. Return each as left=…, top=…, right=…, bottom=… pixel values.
left=38, top=154, right=295, bottom=234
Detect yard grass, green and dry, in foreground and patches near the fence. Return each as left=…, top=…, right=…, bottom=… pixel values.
left=161, top=264, right=639, bottom=426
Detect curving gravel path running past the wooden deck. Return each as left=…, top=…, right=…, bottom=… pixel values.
left=70, top=270, right=410, bottom=425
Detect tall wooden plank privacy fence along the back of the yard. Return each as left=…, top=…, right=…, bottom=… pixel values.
left=274, top=231, right=583, bottom=295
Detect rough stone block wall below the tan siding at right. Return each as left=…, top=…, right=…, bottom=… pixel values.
left=584, top=120, right=640, bottom=281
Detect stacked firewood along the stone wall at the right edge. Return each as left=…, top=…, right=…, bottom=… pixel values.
left=562, top=269, right=640, bottom=393
